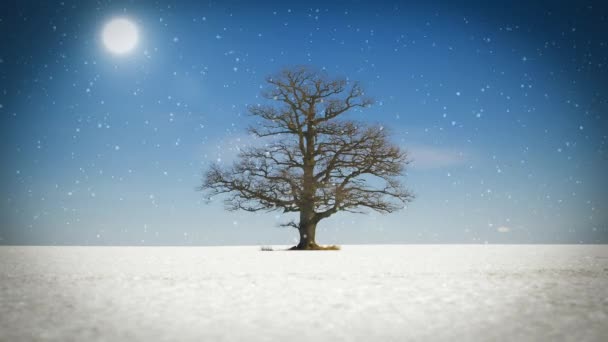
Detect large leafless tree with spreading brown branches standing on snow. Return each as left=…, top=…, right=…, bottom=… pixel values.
left=200, top=67, right=413, bottom=249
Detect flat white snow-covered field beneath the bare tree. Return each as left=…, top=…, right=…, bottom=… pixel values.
left=0, top=245, right=608, bottom=342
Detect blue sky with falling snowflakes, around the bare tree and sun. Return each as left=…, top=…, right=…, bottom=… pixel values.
left=0, top=1, right=608, bottom=245
